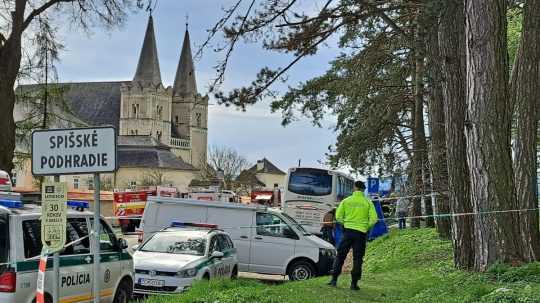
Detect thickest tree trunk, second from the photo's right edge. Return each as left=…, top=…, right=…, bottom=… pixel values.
left=465, top=0, right=523, bottom=271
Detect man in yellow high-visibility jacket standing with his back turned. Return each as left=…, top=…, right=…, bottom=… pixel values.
left=328, top=181, right=378, bottom=290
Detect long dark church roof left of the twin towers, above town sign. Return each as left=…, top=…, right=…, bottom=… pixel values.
left=16, top=81, right=129, bottom=129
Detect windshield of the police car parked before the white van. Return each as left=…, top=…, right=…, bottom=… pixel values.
left=140, top=232, right=206, bottom=256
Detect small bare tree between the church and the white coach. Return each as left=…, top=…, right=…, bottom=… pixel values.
left=208, top=146, right=249, bottom=188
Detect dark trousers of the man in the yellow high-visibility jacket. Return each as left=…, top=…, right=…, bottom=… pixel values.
left=332, top=228, right=367, bottom=285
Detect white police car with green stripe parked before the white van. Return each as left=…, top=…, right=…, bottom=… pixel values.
left=133, top=222, right=238, bottom=294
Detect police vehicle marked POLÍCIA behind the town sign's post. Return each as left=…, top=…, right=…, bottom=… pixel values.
left=0, top=199, right=133, bottom=303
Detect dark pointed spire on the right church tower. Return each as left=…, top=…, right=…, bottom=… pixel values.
left=173, top=27, right=197, bottom=96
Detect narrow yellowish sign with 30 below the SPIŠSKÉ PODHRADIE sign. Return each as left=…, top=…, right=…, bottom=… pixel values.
left=41, top=182, right=67, bottom=251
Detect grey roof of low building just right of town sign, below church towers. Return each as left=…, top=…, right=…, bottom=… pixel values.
left=118, top=136, right=196, bottom=170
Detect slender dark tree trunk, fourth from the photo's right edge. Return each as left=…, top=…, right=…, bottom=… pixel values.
left=427, top=18, right=451, bottom=239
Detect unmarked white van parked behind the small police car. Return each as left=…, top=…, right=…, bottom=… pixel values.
left=141, top=197, right=336, bottom=280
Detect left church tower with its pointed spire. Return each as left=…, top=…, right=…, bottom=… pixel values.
left=119, top=15, right=171, bottom=145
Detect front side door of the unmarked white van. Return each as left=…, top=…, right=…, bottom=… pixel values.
left=249, top=212, right=299, bottom=275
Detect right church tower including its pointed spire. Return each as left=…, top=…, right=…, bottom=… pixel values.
left=171, top=24, right=208, bottom=168
